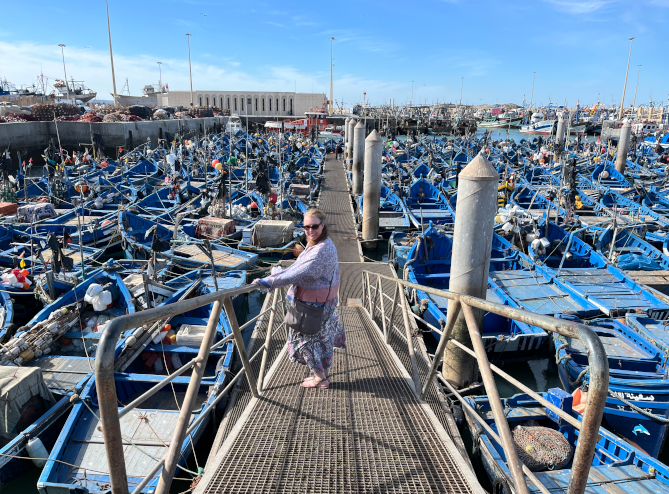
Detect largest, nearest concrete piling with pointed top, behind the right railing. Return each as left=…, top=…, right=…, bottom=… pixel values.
left=440, top=153, right=499, bottom=388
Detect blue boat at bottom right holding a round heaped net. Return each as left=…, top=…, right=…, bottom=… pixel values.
left=465, top=388, right=669, bottom=494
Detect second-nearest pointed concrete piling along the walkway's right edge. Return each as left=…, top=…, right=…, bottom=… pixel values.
left=362, top=127, right=380, bottom=249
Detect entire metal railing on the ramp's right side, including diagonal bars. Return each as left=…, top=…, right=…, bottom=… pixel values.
left=362, top=271, right=609, bottom=494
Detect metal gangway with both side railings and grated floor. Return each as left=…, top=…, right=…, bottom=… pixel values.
left=95, top=157, right=608, bottom=494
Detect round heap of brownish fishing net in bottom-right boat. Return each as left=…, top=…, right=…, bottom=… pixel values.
left=513, top=426, right=573, bottom=472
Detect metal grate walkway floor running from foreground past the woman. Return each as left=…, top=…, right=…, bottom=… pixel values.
left=195, top=155, right=484, bottom=494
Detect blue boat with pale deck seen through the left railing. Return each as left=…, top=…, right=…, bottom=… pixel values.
left=37, top=276, right=233, bottom=493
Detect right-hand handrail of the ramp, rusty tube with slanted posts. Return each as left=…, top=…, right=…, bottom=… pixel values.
left=362, top=270, right=609, bottom=494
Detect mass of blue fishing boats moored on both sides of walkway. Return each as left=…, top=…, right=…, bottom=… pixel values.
left=5, top=119, right=669, bottom=494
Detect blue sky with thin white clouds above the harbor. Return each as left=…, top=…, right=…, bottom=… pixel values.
left=0, top=0, right=669, bottom=106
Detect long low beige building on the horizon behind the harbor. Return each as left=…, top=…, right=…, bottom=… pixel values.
left=158, top=90, right=327, bottom=116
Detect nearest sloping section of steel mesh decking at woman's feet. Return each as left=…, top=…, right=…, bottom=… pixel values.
left=196, top=307, right=471, bottom=493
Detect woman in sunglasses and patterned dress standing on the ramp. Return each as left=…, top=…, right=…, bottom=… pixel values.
left=254, top=209, right=346, bottom=388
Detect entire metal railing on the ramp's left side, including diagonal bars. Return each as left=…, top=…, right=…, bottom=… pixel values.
left=95, top=285, right=285, bottom=494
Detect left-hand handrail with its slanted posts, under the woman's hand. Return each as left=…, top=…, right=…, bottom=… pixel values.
left=95, top=285, right=260, bottom=494
